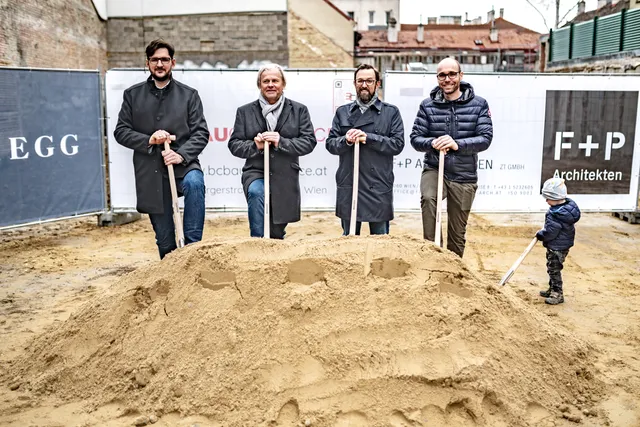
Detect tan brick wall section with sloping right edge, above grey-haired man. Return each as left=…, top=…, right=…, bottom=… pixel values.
left=289, top=11, right=353, bottom=68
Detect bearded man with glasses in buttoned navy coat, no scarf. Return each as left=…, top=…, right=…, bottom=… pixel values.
left=325, top=64, right=404, bottom=236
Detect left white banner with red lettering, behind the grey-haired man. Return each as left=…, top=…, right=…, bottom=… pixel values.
left=106, top=70, right=354, bottom=210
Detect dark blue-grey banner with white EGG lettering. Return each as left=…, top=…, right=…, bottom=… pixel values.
left=0, top=68, right=106, bottom=227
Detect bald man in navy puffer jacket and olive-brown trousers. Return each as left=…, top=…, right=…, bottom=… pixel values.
left=411, top=58, right=493, bottom=257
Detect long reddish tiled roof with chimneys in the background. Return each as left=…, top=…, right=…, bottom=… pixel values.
left=357, top=18, right=540, bottom=52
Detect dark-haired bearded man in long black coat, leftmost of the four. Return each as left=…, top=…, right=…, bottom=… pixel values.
left=113, top=39, right=209, bottom=259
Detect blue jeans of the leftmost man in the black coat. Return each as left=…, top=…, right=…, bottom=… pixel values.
left=149, top=169, right=205, bottom=259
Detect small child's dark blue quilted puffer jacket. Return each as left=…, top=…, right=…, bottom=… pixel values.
left=536, top=199, right=580, bottom=251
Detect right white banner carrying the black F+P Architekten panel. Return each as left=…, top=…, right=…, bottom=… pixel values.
left=385, top=74, right=640, bottom=216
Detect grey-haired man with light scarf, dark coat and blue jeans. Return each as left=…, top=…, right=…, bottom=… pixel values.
left=229, top=64, right=317, bottom=239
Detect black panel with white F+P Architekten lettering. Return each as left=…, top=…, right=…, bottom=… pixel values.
left=541, top=91, right=638, bottom=194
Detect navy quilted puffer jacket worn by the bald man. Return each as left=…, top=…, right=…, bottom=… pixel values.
left=411, top=82, right=493, bottom=183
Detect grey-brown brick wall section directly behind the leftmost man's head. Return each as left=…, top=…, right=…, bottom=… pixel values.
left=107, top=13, right=289, bottom=68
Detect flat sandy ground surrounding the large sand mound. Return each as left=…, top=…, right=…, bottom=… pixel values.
left=0, top=213, right=640, bottom=427
